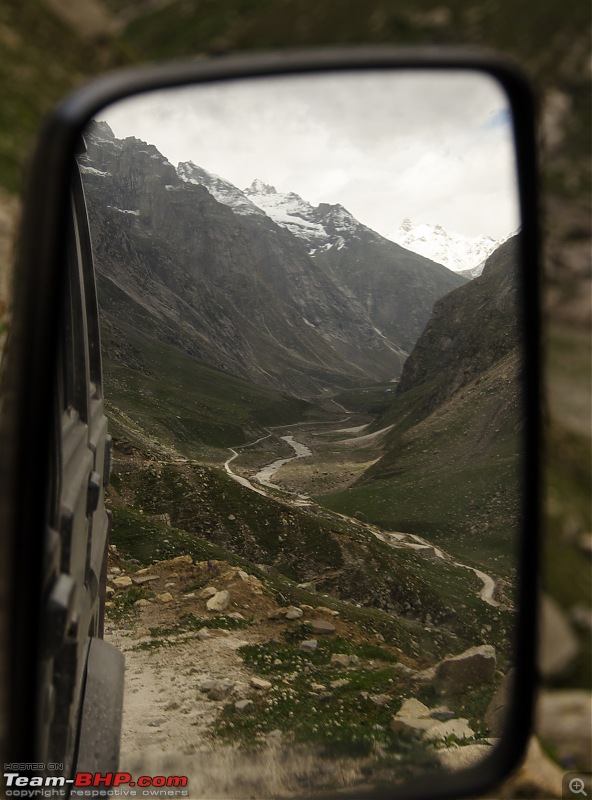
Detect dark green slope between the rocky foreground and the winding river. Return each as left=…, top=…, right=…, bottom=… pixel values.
left=109, top=442, right=512, bottom=658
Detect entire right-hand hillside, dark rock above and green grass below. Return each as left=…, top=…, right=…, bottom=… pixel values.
left=322, top=237, right=522, bottom=575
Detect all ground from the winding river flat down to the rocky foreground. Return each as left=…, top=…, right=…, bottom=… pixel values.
left=105, top=392, right=512, bottom=800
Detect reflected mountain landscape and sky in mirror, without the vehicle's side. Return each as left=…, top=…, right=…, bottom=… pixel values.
left=79, top=71, right=523, bottom=798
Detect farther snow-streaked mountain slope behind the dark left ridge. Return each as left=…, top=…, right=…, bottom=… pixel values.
left=179, top=164, right=466, bottom=352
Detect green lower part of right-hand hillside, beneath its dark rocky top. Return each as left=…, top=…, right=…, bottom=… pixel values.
left=318, top=358, right=519, bottom=575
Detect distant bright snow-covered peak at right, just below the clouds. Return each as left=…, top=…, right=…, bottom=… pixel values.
left=387, top=218, right=508, bottom=278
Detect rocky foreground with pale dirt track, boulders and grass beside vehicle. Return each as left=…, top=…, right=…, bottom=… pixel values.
left=105, top=546, right=504, bottom=798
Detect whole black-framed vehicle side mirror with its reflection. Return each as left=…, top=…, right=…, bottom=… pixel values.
left=0, top=48, right=540, bottom=800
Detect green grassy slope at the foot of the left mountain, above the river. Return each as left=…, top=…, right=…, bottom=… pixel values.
left=103, top=323, right=310, bottom=457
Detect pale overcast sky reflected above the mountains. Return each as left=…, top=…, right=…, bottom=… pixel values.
left=97, top=71, right=519, bottom=239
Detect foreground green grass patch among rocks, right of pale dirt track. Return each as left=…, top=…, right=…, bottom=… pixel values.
left=213, top=631, right=472, bottom=771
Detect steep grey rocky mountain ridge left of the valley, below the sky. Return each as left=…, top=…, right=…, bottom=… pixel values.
left=80, top=123, right=462, bottom=396
